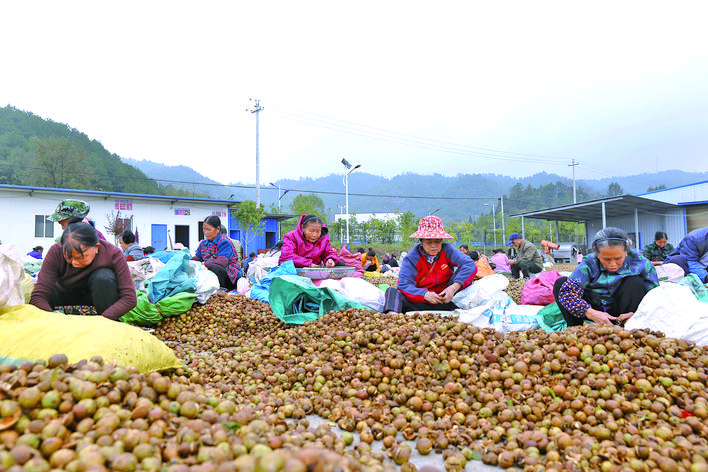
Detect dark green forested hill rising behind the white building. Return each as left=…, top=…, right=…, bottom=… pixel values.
left=0, top=106, right=192, bottom=195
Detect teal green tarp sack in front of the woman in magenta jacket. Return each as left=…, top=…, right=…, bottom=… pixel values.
left=268, top=275, right=369, bottom=324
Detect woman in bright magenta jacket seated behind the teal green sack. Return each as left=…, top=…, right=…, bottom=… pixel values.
left=278, top=215, right=339, bottom=267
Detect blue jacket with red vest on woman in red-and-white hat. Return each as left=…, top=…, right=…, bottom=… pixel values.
left=398, top=243, right=477, bottom=303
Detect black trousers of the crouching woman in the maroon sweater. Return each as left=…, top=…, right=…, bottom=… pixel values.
left=49, top=267, right=118, bottom=315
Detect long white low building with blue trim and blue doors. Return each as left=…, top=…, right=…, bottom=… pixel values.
left=0, top=185, right=289, bottom=254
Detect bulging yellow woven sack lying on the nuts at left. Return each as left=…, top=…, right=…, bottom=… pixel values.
left=0, top=305, right=182, bottom=374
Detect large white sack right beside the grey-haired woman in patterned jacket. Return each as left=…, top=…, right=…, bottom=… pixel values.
left=625, top=284, right=708, bottom=345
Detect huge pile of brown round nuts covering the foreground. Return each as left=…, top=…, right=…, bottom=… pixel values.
left=0, top=295, right=708, bottom=472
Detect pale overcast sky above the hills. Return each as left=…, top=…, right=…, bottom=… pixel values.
left=0, top=0, right=708, bottom=188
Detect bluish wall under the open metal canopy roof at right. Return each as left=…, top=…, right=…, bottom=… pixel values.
left=585, top=208, right=686, bottom=249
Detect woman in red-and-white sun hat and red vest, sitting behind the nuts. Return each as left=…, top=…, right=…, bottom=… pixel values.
left=384, top=215, right=477, bottom=313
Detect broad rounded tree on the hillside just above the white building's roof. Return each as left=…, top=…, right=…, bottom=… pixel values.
left=30, top=137, right=93, bottom=188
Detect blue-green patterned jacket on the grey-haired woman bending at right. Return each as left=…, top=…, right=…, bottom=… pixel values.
left=558, top=247, right=659, bottom=318
